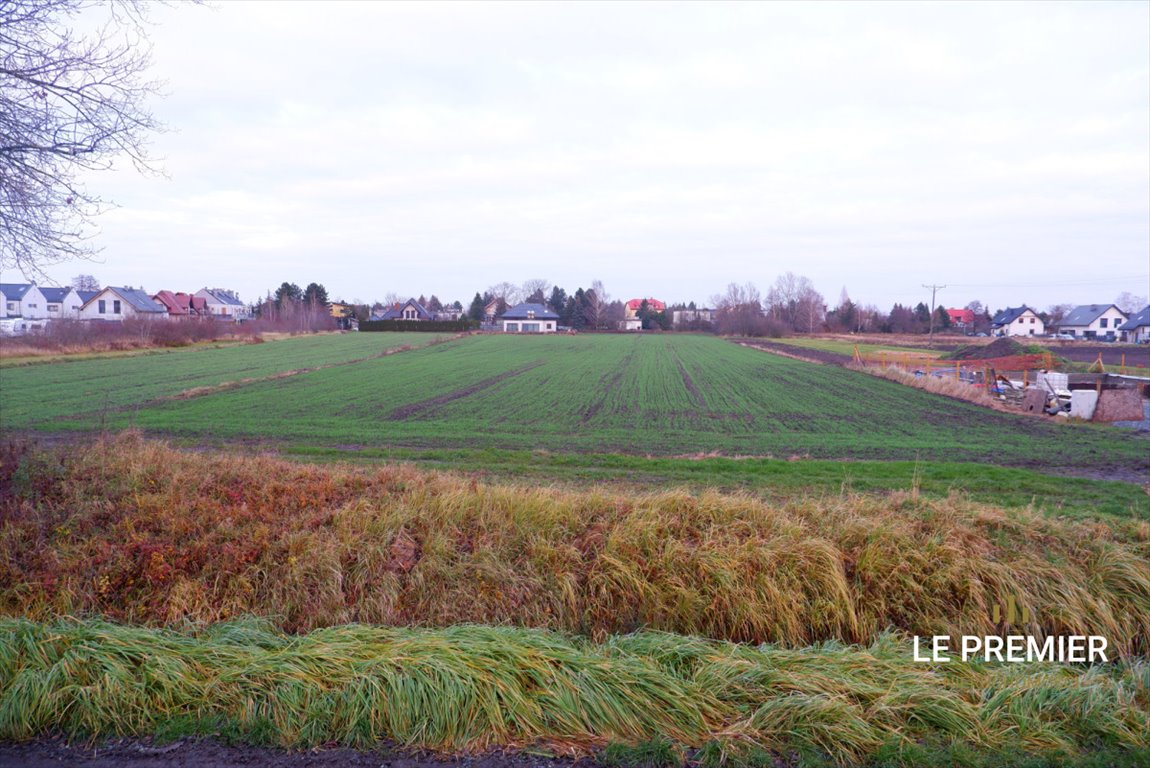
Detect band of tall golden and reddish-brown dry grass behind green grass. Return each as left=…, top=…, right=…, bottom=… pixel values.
left=0, top=435, right=1150, bottom=655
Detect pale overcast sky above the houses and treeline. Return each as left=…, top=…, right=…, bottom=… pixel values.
left=40, top=1, right=1150, bottom=309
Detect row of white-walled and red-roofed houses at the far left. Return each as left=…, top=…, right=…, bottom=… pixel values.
left=0, top=283, right=250, bottom=329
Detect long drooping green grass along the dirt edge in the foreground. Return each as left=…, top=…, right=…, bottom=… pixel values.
left=0, top=620, right=1150, bottom=765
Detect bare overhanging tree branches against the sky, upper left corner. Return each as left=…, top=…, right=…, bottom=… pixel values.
left=0, top=0, right=170, bottom=277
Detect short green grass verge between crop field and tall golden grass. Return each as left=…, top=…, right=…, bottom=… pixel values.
left=280, top=444, right=1150, bottom=520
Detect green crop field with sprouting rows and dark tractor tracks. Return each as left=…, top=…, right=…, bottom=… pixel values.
left=0, top=333, right=1148, bottom=468
